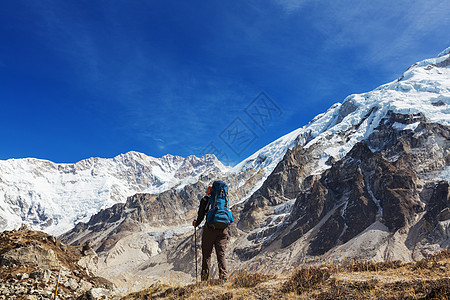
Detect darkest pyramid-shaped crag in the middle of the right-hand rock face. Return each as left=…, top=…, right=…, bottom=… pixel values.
left=282, top=143, right=421, bottom=255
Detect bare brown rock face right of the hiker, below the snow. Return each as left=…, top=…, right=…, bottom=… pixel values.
left=234, top=108, right=450, bottom=260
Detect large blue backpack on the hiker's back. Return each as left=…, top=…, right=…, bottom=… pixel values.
left=206, top=181, right=233, bottom=229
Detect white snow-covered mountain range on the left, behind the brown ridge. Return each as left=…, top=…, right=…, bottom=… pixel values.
left=0, top=152, right=228, bottom=235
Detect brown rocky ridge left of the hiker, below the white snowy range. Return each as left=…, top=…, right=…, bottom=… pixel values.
left=61, top=182, right=207, bottom=252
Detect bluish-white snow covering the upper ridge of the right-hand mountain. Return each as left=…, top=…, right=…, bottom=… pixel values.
left=237, top=47, right=450, bottom=177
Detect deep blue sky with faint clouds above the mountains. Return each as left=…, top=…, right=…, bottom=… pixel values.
left=0, top=0, right=450, bottom=163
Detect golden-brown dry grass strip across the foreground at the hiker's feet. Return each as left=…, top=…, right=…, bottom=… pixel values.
left=124, top=250, right=450, bottom=300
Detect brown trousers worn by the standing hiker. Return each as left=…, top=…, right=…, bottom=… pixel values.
left=202, top=226, right=228, bottom=280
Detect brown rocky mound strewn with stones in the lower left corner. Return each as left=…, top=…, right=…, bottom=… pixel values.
left=0, top=227, right=114, bottom=299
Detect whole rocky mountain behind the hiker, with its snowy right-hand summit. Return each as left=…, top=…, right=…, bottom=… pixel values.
left=63, top=48, right=450, bottom=288
